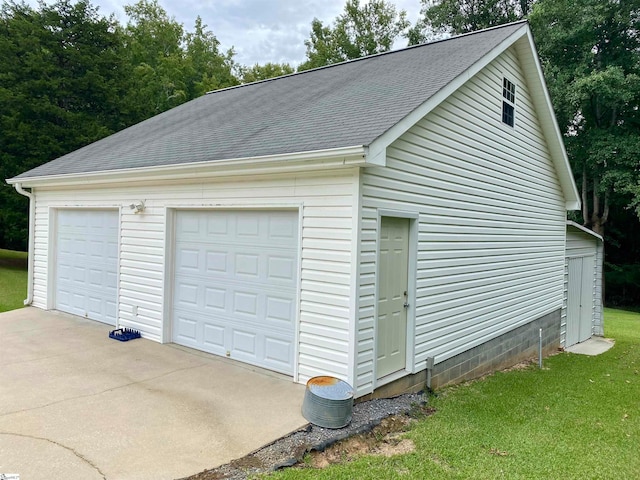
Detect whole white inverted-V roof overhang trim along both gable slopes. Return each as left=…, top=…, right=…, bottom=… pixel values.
left=368, top=22, right=580, bottom=210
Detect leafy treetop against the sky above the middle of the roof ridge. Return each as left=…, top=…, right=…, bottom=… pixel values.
left=298, top=0, right=409, bottom=71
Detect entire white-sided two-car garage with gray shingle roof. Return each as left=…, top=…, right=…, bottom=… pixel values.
left=9, top=22, right=579, bottom=397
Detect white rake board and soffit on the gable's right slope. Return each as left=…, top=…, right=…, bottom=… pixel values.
left=516, top=28, right=581, bottom=210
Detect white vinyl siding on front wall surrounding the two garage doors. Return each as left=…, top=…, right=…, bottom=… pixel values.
left=33, top=168, right=358, bottom=382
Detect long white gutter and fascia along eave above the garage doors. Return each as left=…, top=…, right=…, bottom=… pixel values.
left=6, top=146, right=367, bottom=187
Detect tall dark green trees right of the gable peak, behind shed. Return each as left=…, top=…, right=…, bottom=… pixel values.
left=410, top=0, right=640, bottom=304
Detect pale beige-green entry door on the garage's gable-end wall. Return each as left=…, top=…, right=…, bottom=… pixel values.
left=376, top=217, right=409, bottom=378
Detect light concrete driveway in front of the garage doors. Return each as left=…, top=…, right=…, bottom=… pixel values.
left=0, top=308, right=307, bottom=480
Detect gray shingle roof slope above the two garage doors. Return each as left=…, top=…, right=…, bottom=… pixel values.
left=15, top=23, right=522, bottom=180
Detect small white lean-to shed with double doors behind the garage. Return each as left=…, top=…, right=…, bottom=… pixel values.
left=561, top=221, right=604, bottom=348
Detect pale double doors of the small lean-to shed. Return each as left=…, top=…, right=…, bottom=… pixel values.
left=565, top=256, right=595, bottom=347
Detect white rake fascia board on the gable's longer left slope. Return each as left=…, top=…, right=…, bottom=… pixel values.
left=367, top=23, right=529, bottom=171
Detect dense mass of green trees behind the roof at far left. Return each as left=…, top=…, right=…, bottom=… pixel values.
left=0, top=0, right=239, bottom=249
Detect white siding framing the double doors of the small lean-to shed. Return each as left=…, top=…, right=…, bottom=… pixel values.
left=560, top=226, right=604, bottom=346
